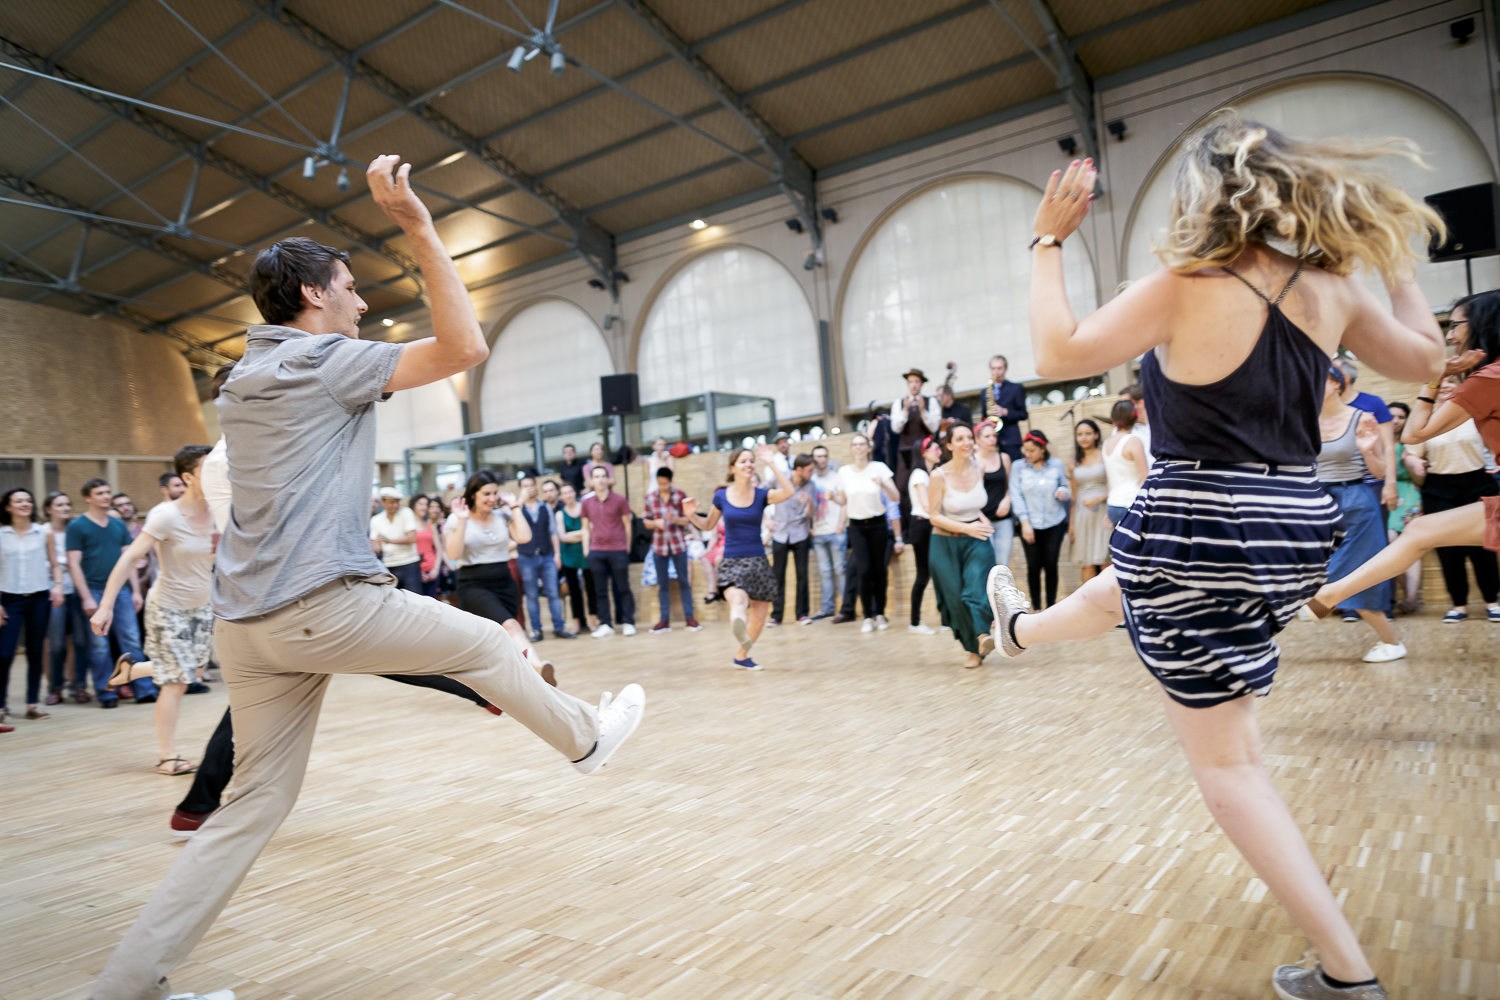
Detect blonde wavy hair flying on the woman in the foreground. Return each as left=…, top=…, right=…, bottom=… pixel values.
left=1154, top=109, right=1446, bottom=282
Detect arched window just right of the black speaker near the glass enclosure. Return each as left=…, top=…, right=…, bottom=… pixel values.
left=636, top=247, right=824, bottom=420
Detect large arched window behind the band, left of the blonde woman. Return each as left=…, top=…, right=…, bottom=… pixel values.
left=840, top=175, right=1095, bottom=406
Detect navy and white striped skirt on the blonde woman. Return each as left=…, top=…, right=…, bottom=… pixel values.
left=1110, top=460, right=1340, bottom=708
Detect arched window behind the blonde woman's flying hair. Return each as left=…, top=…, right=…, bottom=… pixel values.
left=1125, top=73, right=1500, bottom=306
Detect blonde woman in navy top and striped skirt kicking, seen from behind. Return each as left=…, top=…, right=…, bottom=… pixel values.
left=989, top=112, right=1443, bottom=1000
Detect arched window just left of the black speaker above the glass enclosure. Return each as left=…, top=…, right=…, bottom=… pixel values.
left=480, top=298, right=615, bottom=430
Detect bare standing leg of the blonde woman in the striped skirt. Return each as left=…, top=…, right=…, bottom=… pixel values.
left=1163, top=691, right=1374, bottom=982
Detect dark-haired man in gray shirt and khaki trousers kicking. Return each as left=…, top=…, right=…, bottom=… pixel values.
left=93, top=156, right=645, bottom=1000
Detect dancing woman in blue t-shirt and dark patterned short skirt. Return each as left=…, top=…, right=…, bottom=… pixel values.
left=683, top=444, right=795, bottom=670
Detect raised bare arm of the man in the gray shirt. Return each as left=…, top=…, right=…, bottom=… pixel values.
left=365, top=156, right=489, bottom=393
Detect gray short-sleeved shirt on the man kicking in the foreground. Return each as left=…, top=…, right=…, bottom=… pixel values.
left=213, top=327, right=402, bottom=621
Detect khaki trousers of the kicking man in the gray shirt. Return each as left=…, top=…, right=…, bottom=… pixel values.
left=92, top=574, right=599, bottom=1000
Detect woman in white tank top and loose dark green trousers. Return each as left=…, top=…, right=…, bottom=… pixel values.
left=927, top=424, right=995, bottom=669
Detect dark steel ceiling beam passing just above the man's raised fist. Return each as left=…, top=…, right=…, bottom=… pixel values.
left=243, top=0, right=618, bottom=295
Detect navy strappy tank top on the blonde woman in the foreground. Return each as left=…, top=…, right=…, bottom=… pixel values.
left=1140, top=265, right=1329, bottom=465
